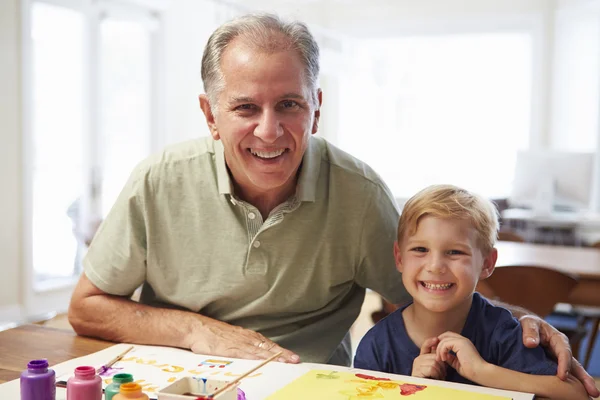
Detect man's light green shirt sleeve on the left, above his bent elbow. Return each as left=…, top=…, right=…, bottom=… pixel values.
left=83, top=165, right=150, bottom=296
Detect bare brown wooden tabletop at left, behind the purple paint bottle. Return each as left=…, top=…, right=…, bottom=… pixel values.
left=0, top=325, right=114, bottom=383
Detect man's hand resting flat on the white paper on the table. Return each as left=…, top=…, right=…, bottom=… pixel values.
left=185, top=319, right=300, bottom=364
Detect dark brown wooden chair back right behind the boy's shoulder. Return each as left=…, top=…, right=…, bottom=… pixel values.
left=477, top=266, right=586, bottom=354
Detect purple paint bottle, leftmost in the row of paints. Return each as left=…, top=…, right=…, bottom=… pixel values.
left=21, top=360, right=56, bottom=400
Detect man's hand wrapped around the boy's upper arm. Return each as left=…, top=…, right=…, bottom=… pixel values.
left=519, top=315, right=600, bottom=398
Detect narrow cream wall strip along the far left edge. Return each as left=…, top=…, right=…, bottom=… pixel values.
left=0, top=0, right=22, bottom=322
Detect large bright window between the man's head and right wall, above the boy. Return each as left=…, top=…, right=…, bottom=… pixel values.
left=338, top=32, right=532, bottom=198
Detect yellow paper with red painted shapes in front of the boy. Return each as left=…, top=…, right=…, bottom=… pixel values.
left=267, top=370, right=511, bottom=400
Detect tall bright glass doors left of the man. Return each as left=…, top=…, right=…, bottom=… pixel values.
left=24, top=0, right=162, bottom=298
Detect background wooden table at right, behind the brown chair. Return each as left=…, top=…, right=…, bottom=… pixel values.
left=496, top=242, right=600, bottom=306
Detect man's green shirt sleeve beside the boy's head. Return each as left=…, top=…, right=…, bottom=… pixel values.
left=356, top=182, right=410, bottom=304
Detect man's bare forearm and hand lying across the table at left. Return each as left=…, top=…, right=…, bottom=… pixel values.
left=69, top=274, right=299, bottom=363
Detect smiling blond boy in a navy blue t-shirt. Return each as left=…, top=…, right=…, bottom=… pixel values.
left=354, top=185, right=588, bottom=400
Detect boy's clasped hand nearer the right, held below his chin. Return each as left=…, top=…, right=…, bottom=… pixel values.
left=436, top=332, right=487, bottom=381
